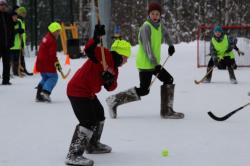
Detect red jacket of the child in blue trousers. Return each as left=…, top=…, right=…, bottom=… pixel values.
left=36, top=32, right=57, bottom=73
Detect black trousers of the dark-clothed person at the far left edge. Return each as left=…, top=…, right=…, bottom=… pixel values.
left=0, top=51, right=11, bottom=83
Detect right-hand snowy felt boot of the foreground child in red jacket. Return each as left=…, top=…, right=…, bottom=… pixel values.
left=86, top=121, right=112, bottom=154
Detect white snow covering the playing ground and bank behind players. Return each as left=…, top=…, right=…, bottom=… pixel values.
left=0, top=42, right=250, bottom=166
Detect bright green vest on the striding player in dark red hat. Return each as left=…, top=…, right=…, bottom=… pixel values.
left=136, top=21, right=162, bottom=69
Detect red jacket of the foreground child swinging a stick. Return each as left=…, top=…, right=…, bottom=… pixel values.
left=67, top=39, right=118, bottom=98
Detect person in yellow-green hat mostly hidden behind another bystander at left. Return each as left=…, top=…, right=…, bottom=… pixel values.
left=16, top=6, right=33, bottom=76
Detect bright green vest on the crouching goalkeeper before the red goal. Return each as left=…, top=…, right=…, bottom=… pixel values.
left=212, top=35, right=234, bottom=60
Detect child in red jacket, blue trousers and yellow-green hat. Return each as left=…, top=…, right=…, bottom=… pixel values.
left=36, top=22, right=61, bottom=102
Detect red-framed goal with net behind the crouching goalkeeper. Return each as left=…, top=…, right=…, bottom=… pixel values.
left=197, top=25, right=250, bottom=67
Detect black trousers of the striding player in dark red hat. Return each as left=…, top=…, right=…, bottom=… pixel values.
left=136, top=68, right=174, bottom=96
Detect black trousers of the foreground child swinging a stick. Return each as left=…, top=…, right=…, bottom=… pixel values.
left=68, top=96, right=105, bottom=130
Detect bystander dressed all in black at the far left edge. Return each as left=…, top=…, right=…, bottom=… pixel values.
left=0, top=0, right=14, bottom=85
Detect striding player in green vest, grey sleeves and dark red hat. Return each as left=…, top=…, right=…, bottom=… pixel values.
left=106, top=2, right=184, bottom=119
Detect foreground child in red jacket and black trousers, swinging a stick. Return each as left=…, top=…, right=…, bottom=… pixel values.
left=66, top=24, right=131, bottom=165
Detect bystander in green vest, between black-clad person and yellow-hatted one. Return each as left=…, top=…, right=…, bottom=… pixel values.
left=10, top=11, right=24, bottom=76
